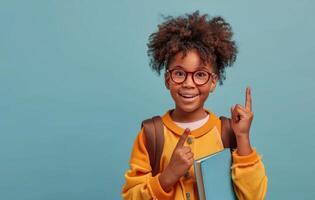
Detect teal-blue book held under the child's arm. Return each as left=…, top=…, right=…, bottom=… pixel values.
left=194, top=148, right=237, bottom=200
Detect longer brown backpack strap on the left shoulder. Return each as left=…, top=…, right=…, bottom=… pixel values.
left=141, top=116, right=164, bottom=176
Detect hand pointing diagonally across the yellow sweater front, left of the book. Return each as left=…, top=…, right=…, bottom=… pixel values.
left=160, top=129, right=194, bottom=192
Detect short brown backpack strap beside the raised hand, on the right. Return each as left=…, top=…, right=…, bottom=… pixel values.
left=220, top=116, right=236, bottom=149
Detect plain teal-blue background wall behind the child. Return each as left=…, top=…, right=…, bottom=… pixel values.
left=0, top=0, right=315, bottom=200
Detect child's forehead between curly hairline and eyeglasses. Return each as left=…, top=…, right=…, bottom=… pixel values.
left=168, top=49, right=212, bottom=71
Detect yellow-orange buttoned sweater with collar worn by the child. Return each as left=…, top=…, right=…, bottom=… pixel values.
left=122, top=110, right=268, bottom=200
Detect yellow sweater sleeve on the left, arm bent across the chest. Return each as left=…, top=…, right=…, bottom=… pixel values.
left=122, top=129, right=174, bottom=200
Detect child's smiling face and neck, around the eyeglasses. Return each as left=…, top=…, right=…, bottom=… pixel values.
left=165, top=49, right=217, bottom=122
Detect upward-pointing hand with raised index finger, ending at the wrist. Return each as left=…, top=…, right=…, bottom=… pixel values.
left=231, top=87, right=254, bottom=140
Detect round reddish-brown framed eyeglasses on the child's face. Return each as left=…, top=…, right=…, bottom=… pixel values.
left=166, top=69, right=217, bottom=86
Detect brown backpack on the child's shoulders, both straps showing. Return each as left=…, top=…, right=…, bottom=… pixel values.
left=141, top=116, right=236, bottom=176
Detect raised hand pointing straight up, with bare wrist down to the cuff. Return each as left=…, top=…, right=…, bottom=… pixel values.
left=231, top=87, right=254, bottom=155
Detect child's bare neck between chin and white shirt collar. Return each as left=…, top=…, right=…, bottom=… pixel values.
left=170, top=107, right=207, bottom=123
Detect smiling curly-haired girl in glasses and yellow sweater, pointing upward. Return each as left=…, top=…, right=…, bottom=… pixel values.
left=122, top=11, right=267, bottom=200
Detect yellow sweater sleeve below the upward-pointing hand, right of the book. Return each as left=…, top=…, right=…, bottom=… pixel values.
left=232, top=149, right=268, bottom=200
